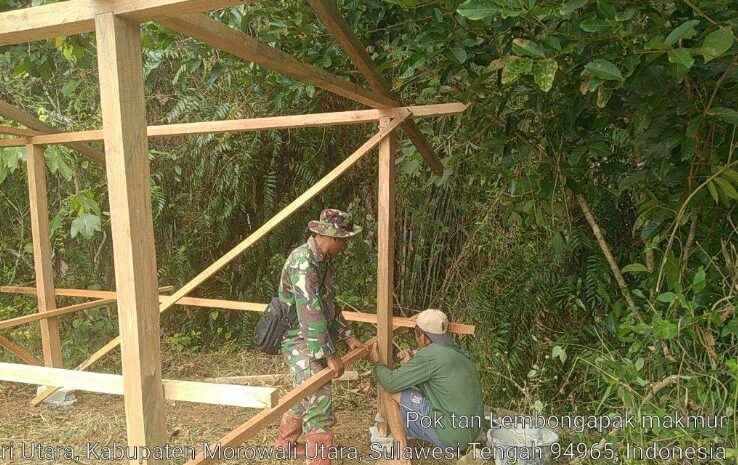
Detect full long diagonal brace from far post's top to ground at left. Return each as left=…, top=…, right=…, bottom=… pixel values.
left=31, top=115, right=410, bottom=405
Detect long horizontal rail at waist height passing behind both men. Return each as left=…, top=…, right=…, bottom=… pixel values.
left=0, top=286, right=476, bottom=335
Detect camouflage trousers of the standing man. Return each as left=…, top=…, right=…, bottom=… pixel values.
left=282, top=338, right=336, bottom=434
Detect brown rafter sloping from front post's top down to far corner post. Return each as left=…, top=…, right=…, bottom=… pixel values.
left=158, top=14, right=395, bottom=107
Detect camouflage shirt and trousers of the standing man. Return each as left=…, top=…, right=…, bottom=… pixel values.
left=279, top=237, right=353, bottom=434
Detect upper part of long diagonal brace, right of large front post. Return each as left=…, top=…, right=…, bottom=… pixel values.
left=160, top=110, right=410, bottom=311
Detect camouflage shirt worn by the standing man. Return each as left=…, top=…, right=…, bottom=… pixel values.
left=279, top=237, right=353, bottom=359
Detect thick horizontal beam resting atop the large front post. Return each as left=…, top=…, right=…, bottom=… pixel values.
left=0, top=0, right=255, bottom=46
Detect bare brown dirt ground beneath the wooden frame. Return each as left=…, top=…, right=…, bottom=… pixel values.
left=0, top=351, right=484, bottom=465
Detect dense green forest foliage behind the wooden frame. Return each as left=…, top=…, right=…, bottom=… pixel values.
left=0, top=0, right=738, bottom=460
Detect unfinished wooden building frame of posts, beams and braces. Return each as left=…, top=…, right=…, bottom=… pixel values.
left=0, top=0, right=474, bottom=465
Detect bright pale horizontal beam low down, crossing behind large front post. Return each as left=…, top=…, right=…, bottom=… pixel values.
left=0, top=363, right=279, bottom=409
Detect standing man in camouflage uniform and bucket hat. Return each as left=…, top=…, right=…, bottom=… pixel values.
left=276, top=208, right=364, bottom=465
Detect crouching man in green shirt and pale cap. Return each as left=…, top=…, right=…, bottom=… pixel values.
left=369, top=309, right=484, bottom=457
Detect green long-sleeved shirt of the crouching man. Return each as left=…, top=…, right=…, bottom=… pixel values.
left=374, top=343, right=485, bottom=448
